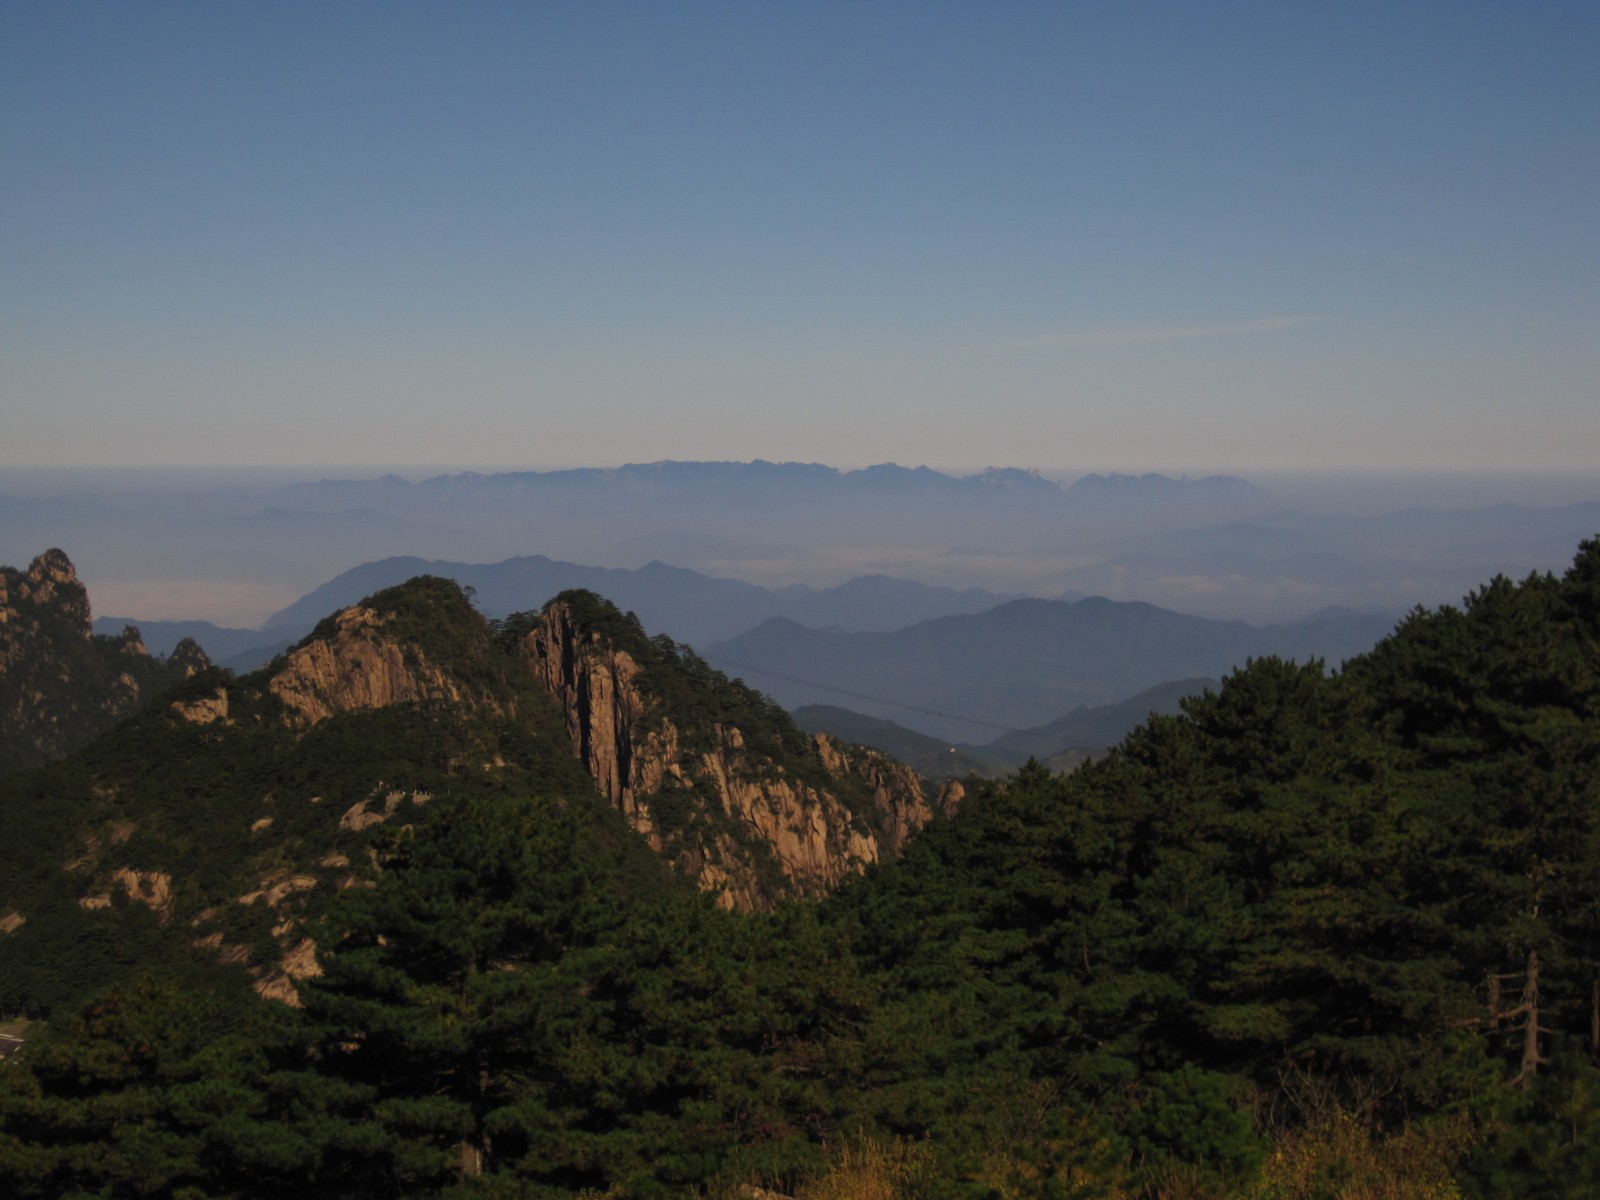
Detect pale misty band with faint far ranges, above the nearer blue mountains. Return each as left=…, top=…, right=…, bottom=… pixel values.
left=18, top=461, right=1600, bottom=642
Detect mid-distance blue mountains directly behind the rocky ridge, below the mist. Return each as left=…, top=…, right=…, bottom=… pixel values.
left=96, top=555, right=1397, bottom=739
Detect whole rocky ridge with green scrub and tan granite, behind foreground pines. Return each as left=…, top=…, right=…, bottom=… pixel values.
left=0, top=555, right=940, bottom=1006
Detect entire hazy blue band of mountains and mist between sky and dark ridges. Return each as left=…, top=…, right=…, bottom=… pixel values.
left=0, top=461, right=1600, bottom=761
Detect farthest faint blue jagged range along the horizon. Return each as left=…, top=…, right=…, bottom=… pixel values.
left=270, top=461, right=1270, bottom=568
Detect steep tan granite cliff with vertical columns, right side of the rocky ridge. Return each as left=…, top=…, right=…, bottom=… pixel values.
left=517, top=598, right=954, bottom=909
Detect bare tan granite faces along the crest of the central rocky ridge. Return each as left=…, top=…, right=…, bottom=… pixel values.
left=228, top=581, right=954, bottom=909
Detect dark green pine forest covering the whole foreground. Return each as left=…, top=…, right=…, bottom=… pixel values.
left=0, top=541, right=1600, bottom=1200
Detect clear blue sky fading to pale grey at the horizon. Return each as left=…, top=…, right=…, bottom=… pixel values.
left=0, top=0, right=1600, bottom=470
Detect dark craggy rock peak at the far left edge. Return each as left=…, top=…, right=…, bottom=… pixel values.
left=0, top=550, right=208, bottom=774
